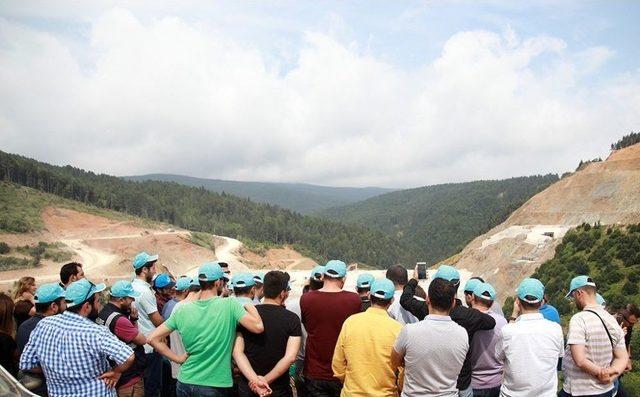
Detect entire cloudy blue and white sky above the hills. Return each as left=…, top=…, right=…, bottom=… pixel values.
left=0, top=0, right=640, bottom=188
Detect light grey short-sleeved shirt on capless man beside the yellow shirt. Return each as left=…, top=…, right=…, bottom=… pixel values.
left=393, top=314, right=469, bottom=397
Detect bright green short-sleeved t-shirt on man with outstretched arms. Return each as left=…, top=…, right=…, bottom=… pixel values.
left=165, top=298, right=246, bottom=387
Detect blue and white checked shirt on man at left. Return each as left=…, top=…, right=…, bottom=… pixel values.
left=20, top=311, right=133, bottom=397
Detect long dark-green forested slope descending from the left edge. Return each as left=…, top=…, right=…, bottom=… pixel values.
left=0, top=151, right=412, bottom=267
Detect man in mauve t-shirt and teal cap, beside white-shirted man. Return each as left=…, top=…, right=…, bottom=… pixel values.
left=465, top=281, right=507, bottom=397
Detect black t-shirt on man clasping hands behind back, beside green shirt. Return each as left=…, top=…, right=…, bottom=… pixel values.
left=239, top=304, right=302, bottom=386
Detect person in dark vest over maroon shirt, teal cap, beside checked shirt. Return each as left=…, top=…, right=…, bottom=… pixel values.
left=96, top=280, right=147, bottom=396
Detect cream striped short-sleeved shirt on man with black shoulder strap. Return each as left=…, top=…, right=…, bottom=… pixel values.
left=562, top=305, right=625, bottom=396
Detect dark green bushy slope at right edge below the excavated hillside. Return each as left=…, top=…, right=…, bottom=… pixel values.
left=533, top=223, right=640, bottom=314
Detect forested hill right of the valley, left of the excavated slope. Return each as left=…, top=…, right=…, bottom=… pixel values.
left=320, top=174, right=558, bottom=262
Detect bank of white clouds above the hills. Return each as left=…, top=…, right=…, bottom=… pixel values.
left=0, top=9, right=640, bottom=186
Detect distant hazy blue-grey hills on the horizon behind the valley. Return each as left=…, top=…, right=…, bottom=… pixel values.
left=123, top=174, right=393, bottom=214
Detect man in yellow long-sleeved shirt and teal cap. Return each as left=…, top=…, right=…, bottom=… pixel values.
left=331, top=278, right=402, bottom=396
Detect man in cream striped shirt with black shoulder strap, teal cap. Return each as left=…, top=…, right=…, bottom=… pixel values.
left=559, top=275, right=629, bottom=396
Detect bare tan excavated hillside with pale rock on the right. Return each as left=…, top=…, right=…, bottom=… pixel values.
left=454, top=144, right=640, bottom=299
